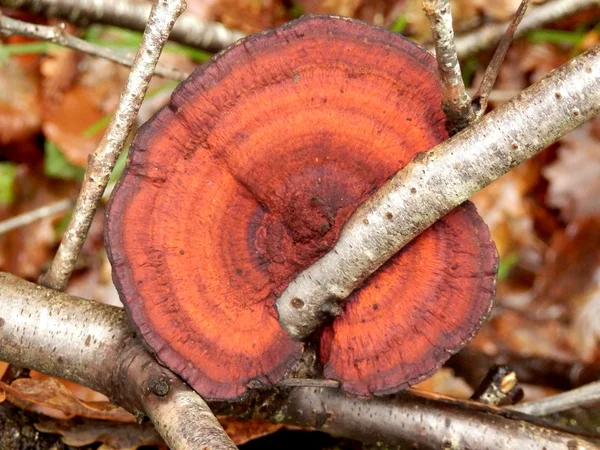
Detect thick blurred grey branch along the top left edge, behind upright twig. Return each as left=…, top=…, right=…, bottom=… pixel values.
left=0, top=0, right=244, bottom=52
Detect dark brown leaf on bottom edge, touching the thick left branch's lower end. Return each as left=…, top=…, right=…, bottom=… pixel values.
left=35, top=421, right=167, bottom=450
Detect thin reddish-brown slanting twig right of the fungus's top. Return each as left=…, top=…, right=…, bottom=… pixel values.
left=473, top=0, right=529, bottom=120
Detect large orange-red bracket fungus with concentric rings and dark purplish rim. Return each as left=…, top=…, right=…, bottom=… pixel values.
left=106, top=16, right=497, bottom=399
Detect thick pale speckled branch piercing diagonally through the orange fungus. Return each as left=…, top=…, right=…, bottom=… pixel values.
left=277, top=45, right=600, bottom=339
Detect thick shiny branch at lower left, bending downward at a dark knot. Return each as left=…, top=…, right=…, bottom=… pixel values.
left=0, top=274, right=236, bottom=450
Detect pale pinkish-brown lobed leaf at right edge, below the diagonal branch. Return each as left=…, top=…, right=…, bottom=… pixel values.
left=544, top=119, right=600, bottom=222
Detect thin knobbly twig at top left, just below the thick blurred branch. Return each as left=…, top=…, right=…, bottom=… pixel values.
left=0, top=12, right=188, bottom=81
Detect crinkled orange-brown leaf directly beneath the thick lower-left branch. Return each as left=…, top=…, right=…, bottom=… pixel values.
left=0, top=378, right=135, bottom=422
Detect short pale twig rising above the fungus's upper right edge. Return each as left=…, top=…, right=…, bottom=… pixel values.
left=423, top=0, right=475, bottom=135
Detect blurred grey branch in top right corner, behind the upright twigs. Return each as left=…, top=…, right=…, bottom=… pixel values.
left=456, top=0, right=600, bottom=60
